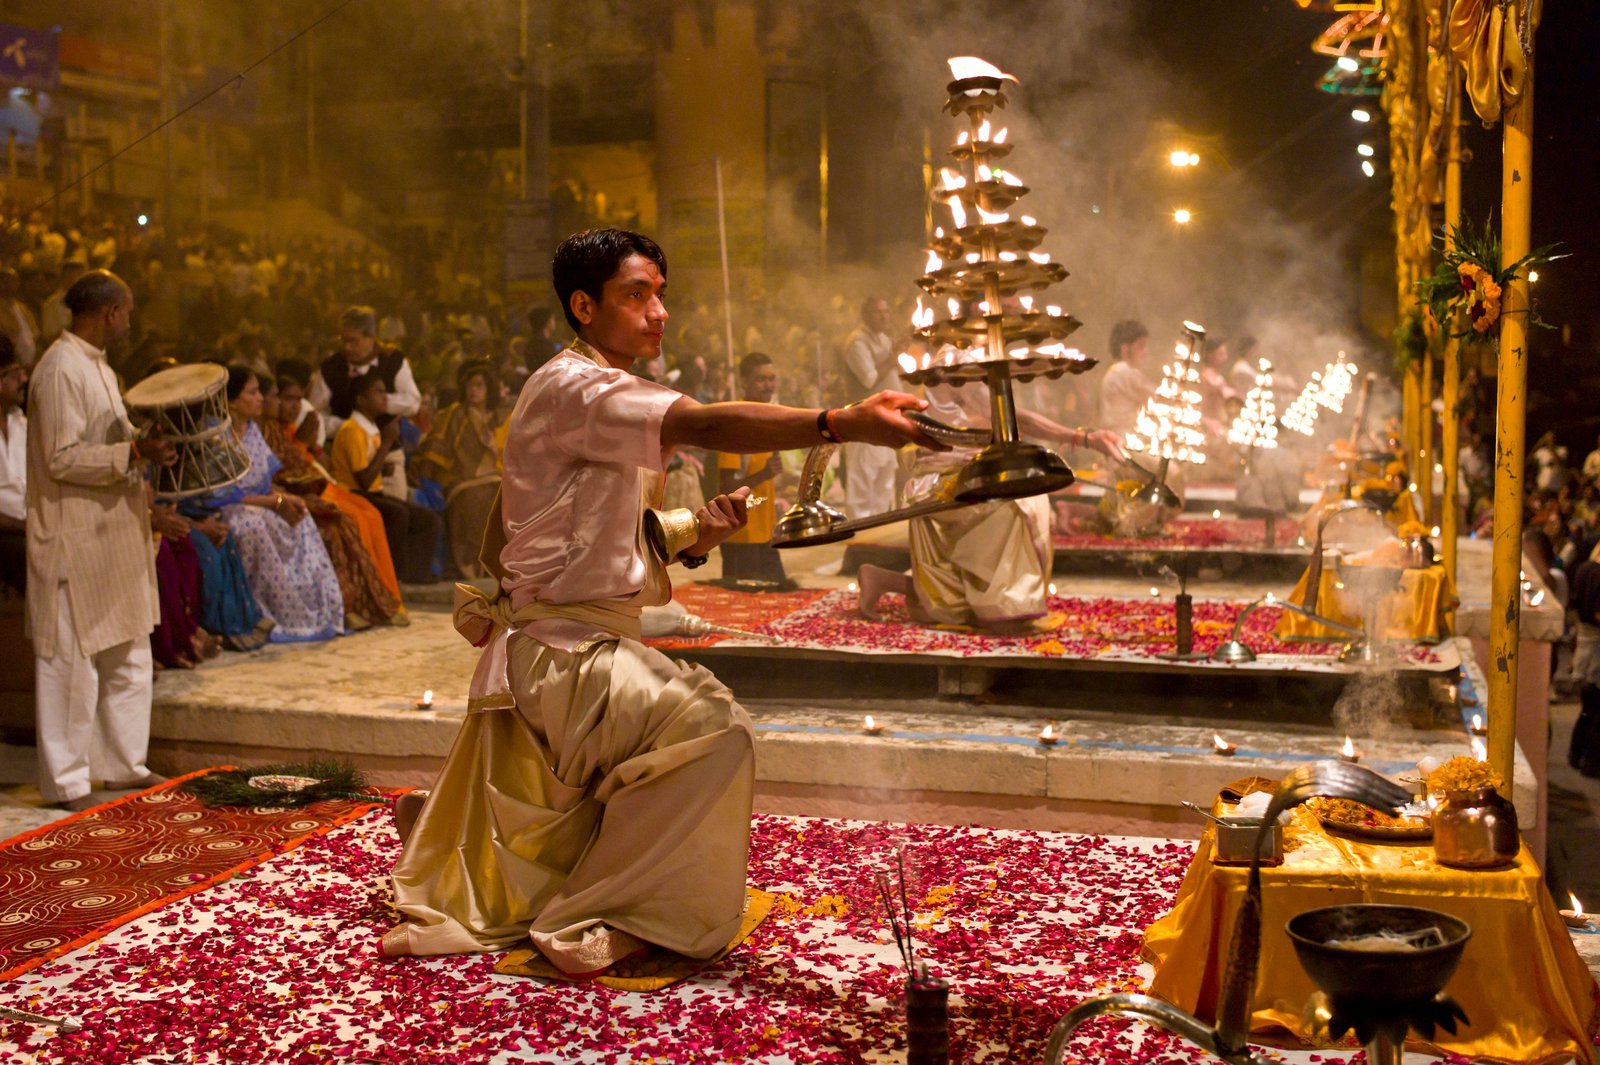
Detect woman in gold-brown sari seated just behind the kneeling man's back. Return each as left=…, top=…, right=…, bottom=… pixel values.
left=411, top=360, right=501, bottom=577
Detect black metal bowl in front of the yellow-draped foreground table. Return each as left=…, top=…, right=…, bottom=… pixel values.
left=1288, top=903, right=1472, bottom=1006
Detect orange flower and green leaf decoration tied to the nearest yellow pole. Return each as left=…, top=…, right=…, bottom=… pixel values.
left=1416, top=215, right=1565, bottom=344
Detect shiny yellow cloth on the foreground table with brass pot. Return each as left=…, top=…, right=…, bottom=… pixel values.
left=1144, top=808, right=1600, bottom=1065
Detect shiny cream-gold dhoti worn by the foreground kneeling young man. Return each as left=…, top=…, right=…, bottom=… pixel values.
left=384, top=585, right=755, bottom=972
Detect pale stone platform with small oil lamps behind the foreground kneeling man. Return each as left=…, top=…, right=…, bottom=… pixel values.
left=0, top=534, right=1549, bottom=852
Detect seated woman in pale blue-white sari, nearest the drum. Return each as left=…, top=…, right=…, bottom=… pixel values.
left=192, top=366, right=344, bottom=643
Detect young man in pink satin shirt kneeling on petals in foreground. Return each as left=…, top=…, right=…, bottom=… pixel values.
left=382, top=229, right=938, bottom=975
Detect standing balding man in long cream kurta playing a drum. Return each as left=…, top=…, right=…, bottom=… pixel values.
left=27, top=270, right=176, bottom=809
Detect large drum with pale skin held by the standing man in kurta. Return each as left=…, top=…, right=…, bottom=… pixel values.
left=123, top=363, right=250, bottom=499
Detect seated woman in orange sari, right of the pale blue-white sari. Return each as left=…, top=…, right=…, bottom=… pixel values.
left=259, top=370, right=408, bottom=632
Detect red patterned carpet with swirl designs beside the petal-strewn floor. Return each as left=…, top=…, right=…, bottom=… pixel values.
left=0, top=771, right=382, bottom=980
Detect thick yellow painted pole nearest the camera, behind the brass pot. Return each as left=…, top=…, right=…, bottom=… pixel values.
left=1488, top=8, right=1533, bottom=795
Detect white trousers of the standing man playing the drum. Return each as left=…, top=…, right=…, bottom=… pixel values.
left=34, top=584, right=152, bottom=803
